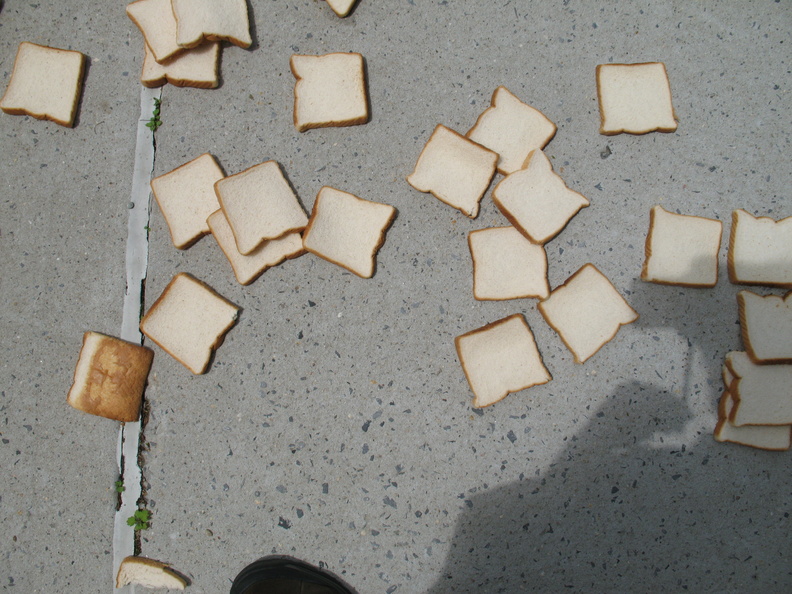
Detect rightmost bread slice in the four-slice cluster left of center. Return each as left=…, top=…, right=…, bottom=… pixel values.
left=303, top=186, right=396, bottom=278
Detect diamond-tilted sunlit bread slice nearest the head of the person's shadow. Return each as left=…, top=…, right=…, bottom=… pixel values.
left=539, top=264, right=638, bottom=363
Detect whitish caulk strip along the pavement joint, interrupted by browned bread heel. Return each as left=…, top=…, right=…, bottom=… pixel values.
left=113, top=87, right=160, bottom=592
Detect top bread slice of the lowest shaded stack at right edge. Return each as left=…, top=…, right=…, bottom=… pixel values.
left=726, top=351, right=792, bottom=427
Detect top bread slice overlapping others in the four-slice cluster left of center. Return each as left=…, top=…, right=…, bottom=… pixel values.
left=213, top=161, right=308, bottom=255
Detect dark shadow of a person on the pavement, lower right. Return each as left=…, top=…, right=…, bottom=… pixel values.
left=429, top=281, right=792, bottom=594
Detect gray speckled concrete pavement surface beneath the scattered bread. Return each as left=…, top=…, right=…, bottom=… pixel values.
left=0, top=0, right=792, bottom=593
